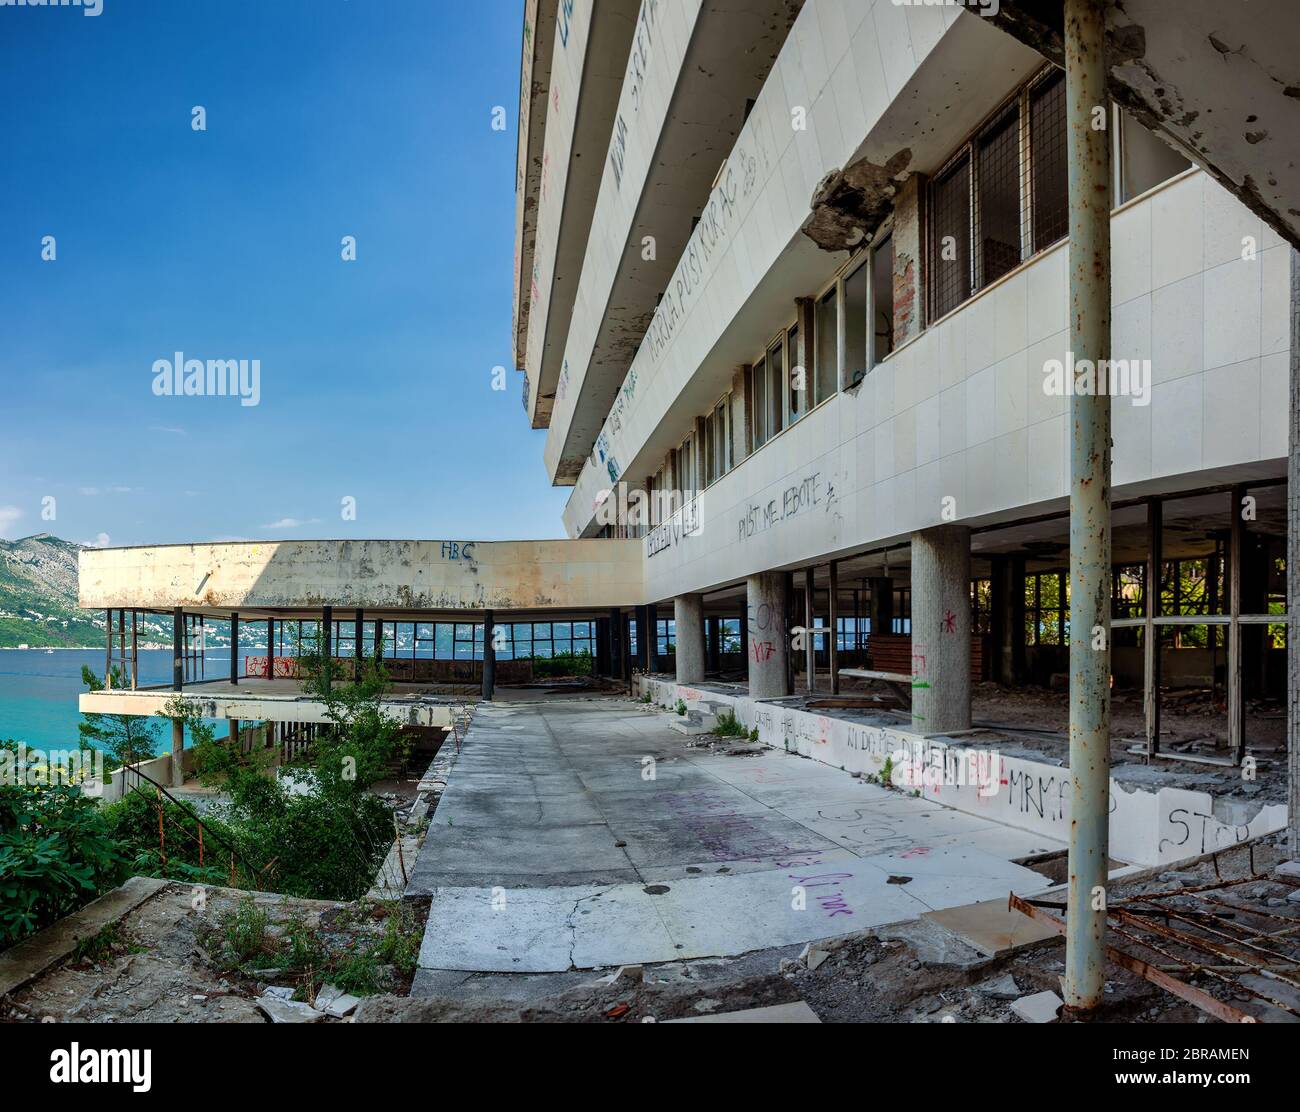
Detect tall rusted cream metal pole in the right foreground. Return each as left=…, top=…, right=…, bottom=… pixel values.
left=1063, top=0, right=1110, bottom=1011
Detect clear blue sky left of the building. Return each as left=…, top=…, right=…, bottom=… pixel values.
left=0, top=0, right=567, bottom=545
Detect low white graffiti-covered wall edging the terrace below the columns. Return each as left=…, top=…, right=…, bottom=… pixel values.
left=637, top=676, right=1287, bottom=865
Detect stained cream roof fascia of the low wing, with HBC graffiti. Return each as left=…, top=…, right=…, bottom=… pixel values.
left=78, top=540, right=642, bottom=616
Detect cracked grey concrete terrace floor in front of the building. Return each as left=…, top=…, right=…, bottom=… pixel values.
left=407, top=700, right=1063, bottom=973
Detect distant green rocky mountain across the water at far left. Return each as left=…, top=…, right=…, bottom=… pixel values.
left=0, top=533, right=166, bottom=649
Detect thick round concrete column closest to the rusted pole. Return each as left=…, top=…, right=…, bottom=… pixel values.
left=911, top=525, right=971, bottom=734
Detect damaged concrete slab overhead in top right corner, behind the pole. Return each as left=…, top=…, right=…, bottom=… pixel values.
left=992, top=0, right=1300, bottom=247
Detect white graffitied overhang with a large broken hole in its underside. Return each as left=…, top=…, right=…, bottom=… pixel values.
left=561, top=5, right=1045, bottom=536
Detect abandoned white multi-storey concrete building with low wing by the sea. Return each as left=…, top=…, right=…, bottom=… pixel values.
left=73, top=0, right=1300, bottom=1014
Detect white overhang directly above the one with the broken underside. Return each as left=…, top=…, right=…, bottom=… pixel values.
left=546, top=0, right=803, bottom=485
